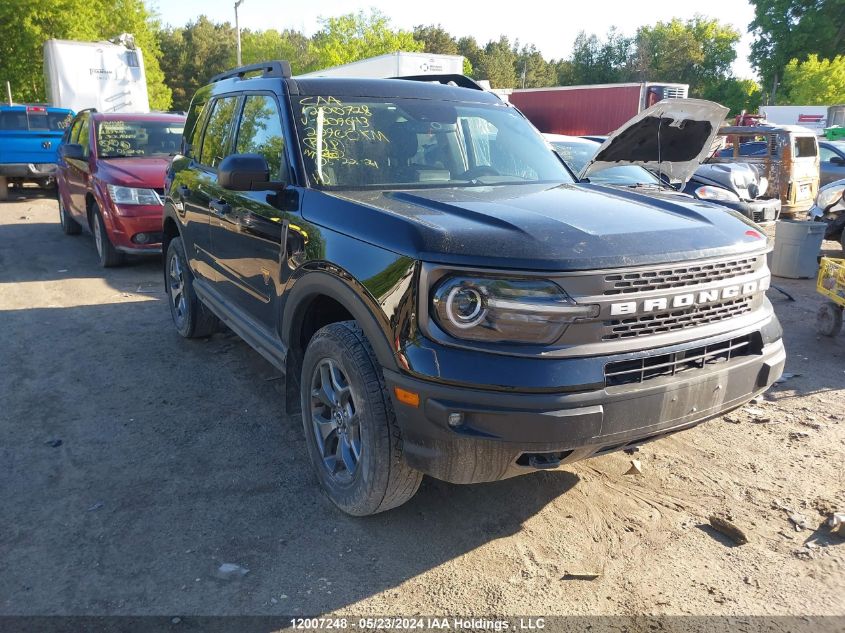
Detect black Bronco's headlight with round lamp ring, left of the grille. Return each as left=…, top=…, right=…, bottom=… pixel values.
left=432, top=276, right=599, bottom=345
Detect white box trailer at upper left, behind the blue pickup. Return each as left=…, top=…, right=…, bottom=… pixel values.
left=44, top=40, right=150, bottom=112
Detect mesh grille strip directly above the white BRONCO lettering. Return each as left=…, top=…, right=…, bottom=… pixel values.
left=604, top=257, right=758, bottom=295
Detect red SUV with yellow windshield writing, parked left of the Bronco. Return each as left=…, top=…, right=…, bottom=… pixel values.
left=56, top=110, right=185, bottom=267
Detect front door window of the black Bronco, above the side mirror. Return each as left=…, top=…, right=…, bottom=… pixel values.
left=236, top=95, right=287, bottom=180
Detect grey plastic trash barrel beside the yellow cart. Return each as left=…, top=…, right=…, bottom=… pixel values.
left=772, top=220, right=827, bottom=279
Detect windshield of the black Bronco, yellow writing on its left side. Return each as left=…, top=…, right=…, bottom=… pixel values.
left=294, top=96, right=572, bottom=189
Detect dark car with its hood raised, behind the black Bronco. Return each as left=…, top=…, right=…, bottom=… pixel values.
left=544, top=99, right=781, bottom=223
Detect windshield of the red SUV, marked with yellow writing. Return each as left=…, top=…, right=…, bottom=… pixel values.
left=97, top=120, right=185, bottom=158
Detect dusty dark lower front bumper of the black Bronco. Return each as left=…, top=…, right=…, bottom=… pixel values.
left=384, top=317, right=786, bottom=483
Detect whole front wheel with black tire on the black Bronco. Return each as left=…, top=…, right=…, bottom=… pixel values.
left=300, top=321, right=422, bottom=516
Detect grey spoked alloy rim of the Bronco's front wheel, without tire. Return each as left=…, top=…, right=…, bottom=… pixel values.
left=309, top=358, right=361, bottom=483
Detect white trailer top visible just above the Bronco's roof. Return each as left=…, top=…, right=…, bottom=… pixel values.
left=301, top=52, right=464, bottom=79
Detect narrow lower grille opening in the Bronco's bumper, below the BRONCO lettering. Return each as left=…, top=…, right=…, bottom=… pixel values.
left=604, top=334, right=760, bottom=387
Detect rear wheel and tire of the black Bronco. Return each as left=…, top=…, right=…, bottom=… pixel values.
left=164, top=237, right=219, bottom=338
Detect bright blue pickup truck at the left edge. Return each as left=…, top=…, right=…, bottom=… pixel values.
left=0, top=105, right=73, bottom=200
